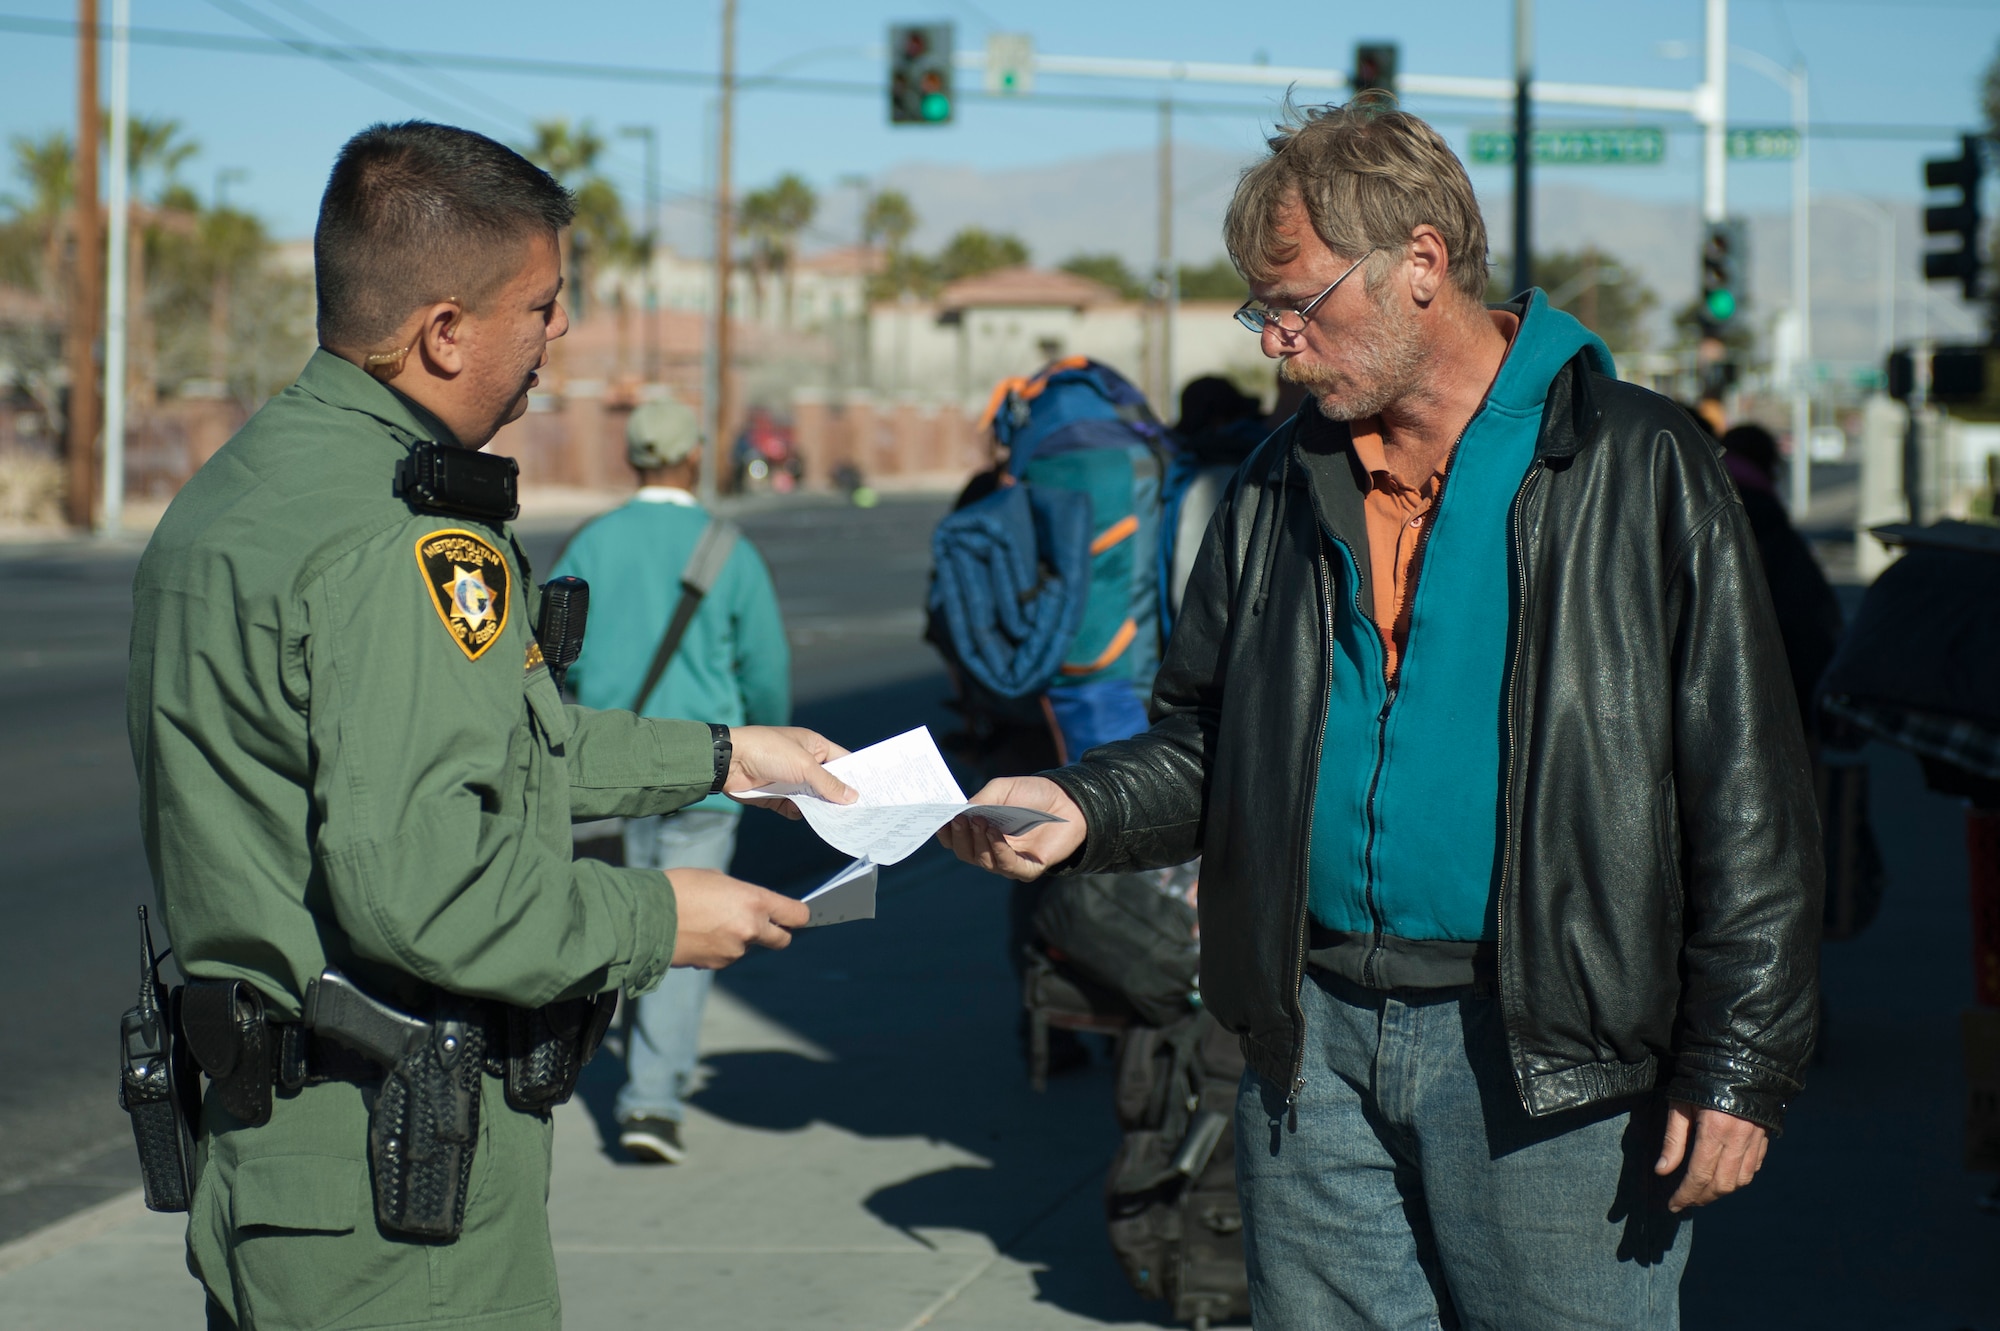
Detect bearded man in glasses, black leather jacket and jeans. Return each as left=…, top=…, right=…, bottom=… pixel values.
left=942, top=98, right=1822, bottom=1331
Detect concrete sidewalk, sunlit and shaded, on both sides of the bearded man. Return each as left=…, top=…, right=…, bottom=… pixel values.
left=0, top=749, right=2000, bottom=1331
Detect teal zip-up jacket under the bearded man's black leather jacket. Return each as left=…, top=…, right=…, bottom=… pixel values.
left=1310, top=292, right=1612, bottom=943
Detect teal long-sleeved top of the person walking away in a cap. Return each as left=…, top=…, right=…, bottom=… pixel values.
left=552, top=492, right=792, bottom=809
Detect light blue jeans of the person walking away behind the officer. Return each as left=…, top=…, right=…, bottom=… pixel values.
left=616, top=809, right=742, bottom=1123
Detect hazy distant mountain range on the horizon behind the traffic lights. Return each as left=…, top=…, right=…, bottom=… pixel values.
left=668, top=144, right=1982, bottom=366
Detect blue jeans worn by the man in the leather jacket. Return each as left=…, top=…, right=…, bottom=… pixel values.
left=1236, top=973, right=1690, bottom=1331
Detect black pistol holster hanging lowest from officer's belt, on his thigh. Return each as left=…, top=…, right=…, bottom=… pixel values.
left=368, top=993, right=486, bottom=1241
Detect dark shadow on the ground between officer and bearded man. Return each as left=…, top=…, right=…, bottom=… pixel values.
left=578, top=673, right=1164, bottom=1323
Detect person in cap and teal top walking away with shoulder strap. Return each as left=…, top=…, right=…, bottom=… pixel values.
left=554, top=402, right=792, bottom=1165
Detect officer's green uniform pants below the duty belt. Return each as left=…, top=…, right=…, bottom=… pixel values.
left=188, top=1077, right=562, bottom=1331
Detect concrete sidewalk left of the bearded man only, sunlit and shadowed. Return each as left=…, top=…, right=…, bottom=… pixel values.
left=0, top=847, right=1160, bottom=1331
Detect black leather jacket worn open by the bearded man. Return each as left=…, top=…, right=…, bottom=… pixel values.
left=1048, top=358, right=1824, bottom=1129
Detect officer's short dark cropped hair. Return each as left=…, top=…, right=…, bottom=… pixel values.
left=312, top=120, right=576, bottom=350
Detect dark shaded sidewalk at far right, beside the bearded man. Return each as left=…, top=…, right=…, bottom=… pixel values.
left=1682, top=745, right=2000, bottom=1331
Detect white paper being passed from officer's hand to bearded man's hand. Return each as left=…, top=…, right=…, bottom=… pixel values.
left=746, top=725, right=1062, bottom=865
